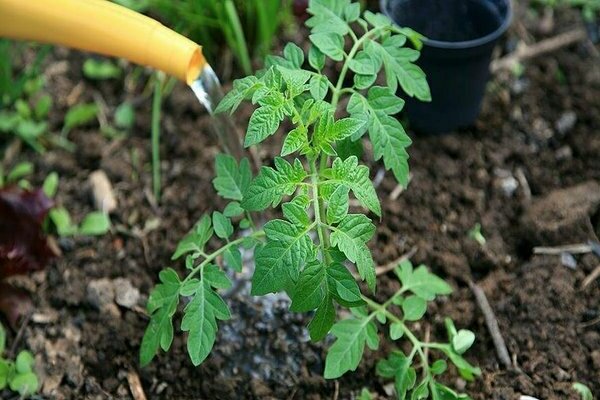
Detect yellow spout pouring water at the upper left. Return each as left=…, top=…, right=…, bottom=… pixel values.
left=0, top=0, right=206, bottom=84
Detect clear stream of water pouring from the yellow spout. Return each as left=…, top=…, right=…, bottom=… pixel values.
left=190, top=64, right=244, bottom=160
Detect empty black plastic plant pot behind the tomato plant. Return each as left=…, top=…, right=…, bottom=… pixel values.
left=381, top=0, right=512, bottom=134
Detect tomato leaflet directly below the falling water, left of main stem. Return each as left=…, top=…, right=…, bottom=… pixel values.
left=213, top=154, right=252, bottom=201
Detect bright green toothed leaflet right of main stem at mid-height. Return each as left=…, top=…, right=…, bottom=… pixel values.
left=325, top=156, right=381, bottom=216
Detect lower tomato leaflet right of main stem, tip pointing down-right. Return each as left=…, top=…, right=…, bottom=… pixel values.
left=331, top=214, right=375, bottom=290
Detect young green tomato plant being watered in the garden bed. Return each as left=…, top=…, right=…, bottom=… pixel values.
left=141, top=0, right=480, bottom=399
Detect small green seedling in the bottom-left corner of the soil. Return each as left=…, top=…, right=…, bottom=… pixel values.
left=0, top=324, right=39, bottom=397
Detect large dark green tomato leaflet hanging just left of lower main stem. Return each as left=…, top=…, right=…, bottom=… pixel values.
left=251, top=220, right=314, bottom=296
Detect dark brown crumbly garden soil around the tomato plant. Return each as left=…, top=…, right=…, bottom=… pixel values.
left=0, top=1, right=600, bottom=400
